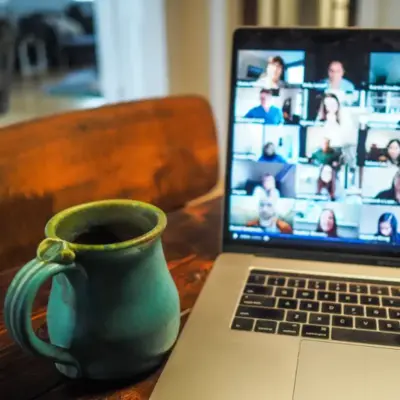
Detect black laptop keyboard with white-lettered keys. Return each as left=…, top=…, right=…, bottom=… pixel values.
left=231, top=270, right=400, bottom=347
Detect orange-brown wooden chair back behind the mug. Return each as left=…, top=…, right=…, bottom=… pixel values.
left=0, top=96, right=218, bottom=261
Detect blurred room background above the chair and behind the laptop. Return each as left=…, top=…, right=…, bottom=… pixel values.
left=0, top=0, right=400, bottom=171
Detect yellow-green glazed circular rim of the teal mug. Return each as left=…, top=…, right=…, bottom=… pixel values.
left=45, top=199, right=167, bottom=251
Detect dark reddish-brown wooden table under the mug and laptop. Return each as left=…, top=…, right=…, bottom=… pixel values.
left=0, top=198, right=222, bottom=400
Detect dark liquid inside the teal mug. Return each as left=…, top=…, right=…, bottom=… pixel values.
left=71, top=222, right=147, bottom=244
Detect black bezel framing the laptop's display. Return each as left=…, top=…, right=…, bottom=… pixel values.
left=222, top=27, right=400, bottom=266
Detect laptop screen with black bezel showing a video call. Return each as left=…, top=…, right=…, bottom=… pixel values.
left=225, top=29, right=400, bottom=252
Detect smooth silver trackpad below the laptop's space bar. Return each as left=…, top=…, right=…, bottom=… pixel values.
left=293, top=340, right=400, bottom=400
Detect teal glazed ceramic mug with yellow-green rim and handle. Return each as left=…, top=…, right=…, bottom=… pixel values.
left=4, top=200, right=180, bottom=379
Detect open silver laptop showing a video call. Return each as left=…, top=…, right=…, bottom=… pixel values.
left=151, top=28, right=400, bottom=400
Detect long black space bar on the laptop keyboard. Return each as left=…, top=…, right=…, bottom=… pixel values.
left=331, top=328, right=400, bottom=346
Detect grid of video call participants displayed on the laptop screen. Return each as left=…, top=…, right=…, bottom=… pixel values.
left=231, top=51, right=400, bottom=243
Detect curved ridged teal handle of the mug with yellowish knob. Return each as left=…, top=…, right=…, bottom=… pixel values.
left=4, top=239, right=87, bottom=375
